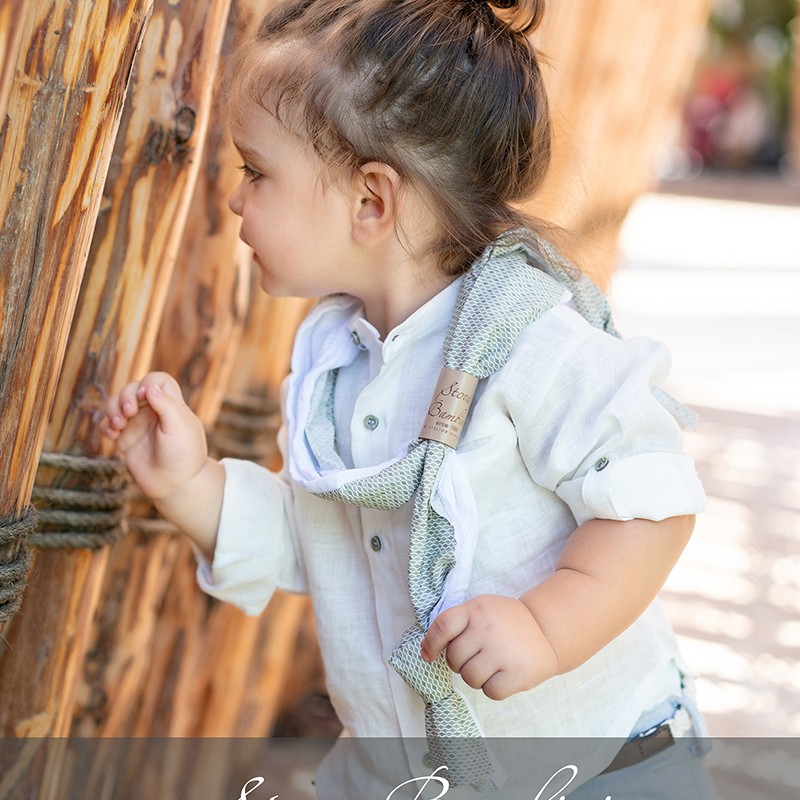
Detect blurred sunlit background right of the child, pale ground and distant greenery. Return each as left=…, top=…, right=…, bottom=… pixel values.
left=611, top=0, right=800, bottom=736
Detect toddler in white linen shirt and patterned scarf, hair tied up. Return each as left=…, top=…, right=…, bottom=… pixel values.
left=101, top=0, right=707, bottom=800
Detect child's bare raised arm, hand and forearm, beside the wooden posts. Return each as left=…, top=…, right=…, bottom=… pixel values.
left=100, top=372, right=225, bottom=560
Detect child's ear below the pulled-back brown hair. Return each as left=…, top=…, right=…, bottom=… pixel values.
left=352, top=161, right=400, bottom=244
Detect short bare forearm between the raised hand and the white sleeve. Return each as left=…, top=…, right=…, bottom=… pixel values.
left=153, top=458, right=225, bottom=561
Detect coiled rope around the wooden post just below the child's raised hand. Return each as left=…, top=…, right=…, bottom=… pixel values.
left=31, top=453, right=130, bottom=550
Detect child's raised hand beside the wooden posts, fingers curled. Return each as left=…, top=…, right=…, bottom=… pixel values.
left=100, top=372, right=208, bottom=500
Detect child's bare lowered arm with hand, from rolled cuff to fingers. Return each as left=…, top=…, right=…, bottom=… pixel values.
left=422, top=516, right=694, bottom=700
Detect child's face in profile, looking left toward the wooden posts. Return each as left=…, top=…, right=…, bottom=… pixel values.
left=229, top=105, right=358, bottom=297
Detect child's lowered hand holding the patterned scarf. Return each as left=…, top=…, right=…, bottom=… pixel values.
left=422, top=594, right=558, bottom=700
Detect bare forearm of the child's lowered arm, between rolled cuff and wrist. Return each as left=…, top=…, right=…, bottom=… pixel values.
left=520, top=516, right=694, bottom=674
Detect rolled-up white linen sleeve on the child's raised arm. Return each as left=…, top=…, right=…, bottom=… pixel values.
left=194, top=459, right=307, bottom=615
